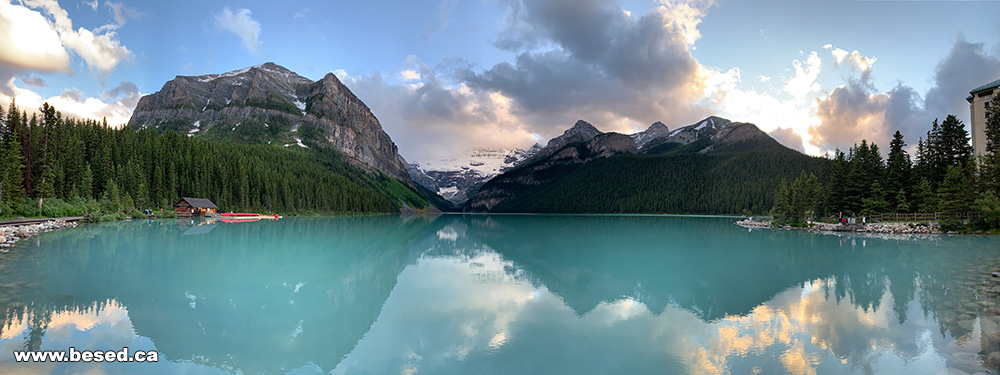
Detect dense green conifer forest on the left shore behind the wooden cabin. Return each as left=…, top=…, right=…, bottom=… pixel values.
left=0, top=101, right=426, bottom=222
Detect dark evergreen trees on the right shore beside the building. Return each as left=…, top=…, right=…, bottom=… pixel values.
left=772, top=95, right=1000, bottom=230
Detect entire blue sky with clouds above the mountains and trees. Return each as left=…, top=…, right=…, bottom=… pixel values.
left=0, top=0, right=1000, bottom=161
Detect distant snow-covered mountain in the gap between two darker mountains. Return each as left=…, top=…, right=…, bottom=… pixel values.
left=404, top=144, right=542, bottom=205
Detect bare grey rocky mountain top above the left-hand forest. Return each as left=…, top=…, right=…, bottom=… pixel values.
left=129, top=62, right=410, bottom=181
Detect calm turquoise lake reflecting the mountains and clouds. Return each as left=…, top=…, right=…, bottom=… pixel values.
left=0, top=215, right=1000, bottom=374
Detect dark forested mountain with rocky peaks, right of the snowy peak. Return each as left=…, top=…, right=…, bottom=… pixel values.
left=464, top=116, right=825, bottom=214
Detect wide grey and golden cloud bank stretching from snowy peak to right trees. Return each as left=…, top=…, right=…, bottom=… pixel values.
left=337, top=0, right=1000, bottom=161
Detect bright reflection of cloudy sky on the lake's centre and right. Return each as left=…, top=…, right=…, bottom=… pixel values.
left=334, top=245, right=979, bottom=374
